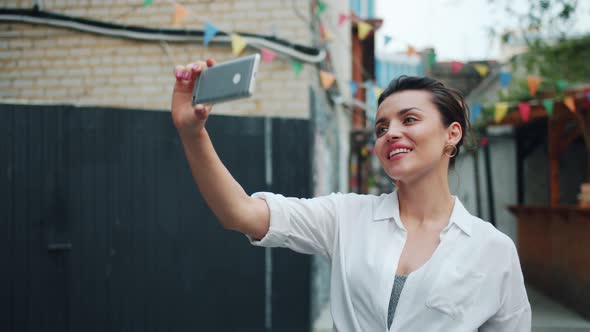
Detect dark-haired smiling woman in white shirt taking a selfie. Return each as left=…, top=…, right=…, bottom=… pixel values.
left=172, top=60, right=531, bottom=332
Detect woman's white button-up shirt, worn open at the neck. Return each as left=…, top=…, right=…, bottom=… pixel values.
left=250, top=192, right=531, bottom=332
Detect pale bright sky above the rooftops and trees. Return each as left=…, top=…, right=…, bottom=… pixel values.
left=375, top=0, right=590, bottom=61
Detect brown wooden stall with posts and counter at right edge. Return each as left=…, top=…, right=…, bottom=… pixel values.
left=502, top=89, right=590, bottom=318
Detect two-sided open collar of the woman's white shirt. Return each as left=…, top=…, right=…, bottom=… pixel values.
left=373, top=190, right=473, bottom=236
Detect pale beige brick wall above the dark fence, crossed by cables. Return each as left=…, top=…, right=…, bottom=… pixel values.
left=0, top=0, right=317, bottom=118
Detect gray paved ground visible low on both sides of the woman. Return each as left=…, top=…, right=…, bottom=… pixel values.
left=313, top=287, right=590, bottom=332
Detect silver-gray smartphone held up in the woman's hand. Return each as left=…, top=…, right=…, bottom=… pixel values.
left=193, top=54, right=260, bottom=105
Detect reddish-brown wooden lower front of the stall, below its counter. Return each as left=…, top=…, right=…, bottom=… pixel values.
left=510, top=206, right=590, bottom=319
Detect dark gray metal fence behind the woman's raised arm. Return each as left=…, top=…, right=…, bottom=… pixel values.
left=0, top=105, right=311, bottom=332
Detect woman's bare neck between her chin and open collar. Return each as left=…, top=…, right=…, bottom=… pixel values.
left=398, top=163, right=454, bottom=229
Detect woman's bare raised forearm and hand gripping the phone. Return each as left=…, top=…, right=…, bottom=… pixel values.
left=172, top=59, right=270, bottom=239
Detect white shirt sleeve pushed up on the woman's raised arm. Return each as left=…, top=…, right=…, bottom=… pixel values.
left=246, top=192, right=342, bottom=258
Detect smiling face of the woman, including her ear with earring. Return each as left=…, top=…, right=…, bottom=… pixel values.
left=375, top=90, right=461, bottom=182
